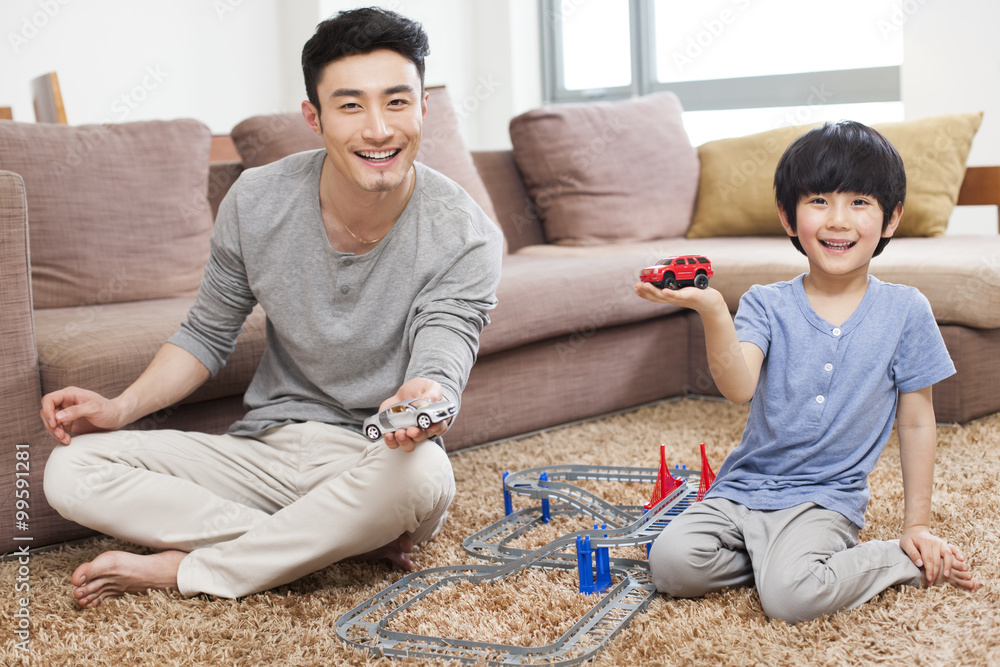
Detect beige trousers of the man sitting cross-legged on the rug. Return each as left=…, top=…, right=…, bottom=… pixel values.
left=45, top=422, right=455, bottom=597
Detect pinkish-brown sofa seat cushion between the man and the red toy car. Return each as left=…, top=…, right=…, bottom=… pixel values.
left=480, top=255, right=680, bottom=355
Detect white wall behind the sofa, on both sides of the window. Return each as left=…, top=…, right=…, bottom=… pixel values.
left=0, top=0, right=1000, bottom=164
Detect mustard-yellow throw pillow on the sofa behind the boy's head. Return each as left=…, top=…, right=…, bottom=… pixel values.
left=687, top=112, right=982, bottom=238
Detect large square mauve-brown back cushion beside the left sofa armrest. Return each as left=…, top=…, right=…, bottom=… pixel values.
left=0, top=120, right=212, bottom=308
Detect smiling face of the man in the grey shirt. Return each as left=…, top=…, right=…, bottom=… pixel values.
left=302, top=49, right=427, bottom=193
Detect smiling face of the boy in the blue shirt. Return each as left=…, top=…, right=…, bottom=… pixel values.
left=778, top=192, right=903, bottom=276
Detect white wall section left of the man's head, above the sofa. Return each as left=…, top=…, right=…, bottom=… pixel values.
left=0, top=0, right=292, bottom=134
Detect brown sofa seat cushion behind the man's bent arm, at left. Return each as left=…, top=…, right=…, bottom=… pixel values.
left=35, top=297, right=265, bottom=410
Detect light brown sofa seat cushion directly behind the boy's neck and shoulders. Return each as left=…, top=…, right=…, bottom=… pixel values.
left=514, top=236, right=1000, bottom=329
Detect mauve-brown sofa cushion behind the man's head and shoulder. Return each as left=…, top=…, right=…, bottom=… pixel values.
left=231, top=86, right=497, bottom=227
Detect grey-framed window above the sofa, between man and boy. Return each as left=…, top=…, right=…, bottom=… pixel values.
left=542, top=0, right=906, bottom=144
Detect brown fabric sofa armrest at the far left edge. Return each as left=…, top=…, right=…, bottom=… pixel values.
left=0, top=171, right=55, bottom=552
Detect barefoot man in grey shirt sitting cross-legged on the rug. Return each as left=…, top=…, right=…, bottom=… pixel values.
left=41, top=9, right=502, bottom=607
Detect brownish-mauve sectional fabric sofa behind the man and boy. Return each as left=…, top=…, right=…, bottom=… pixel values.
left=0, top=89, right=1000, bottom=552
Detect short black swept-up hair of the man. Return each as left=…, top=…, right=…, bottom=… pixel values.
left=302, top=7, right=430, bottom=111
